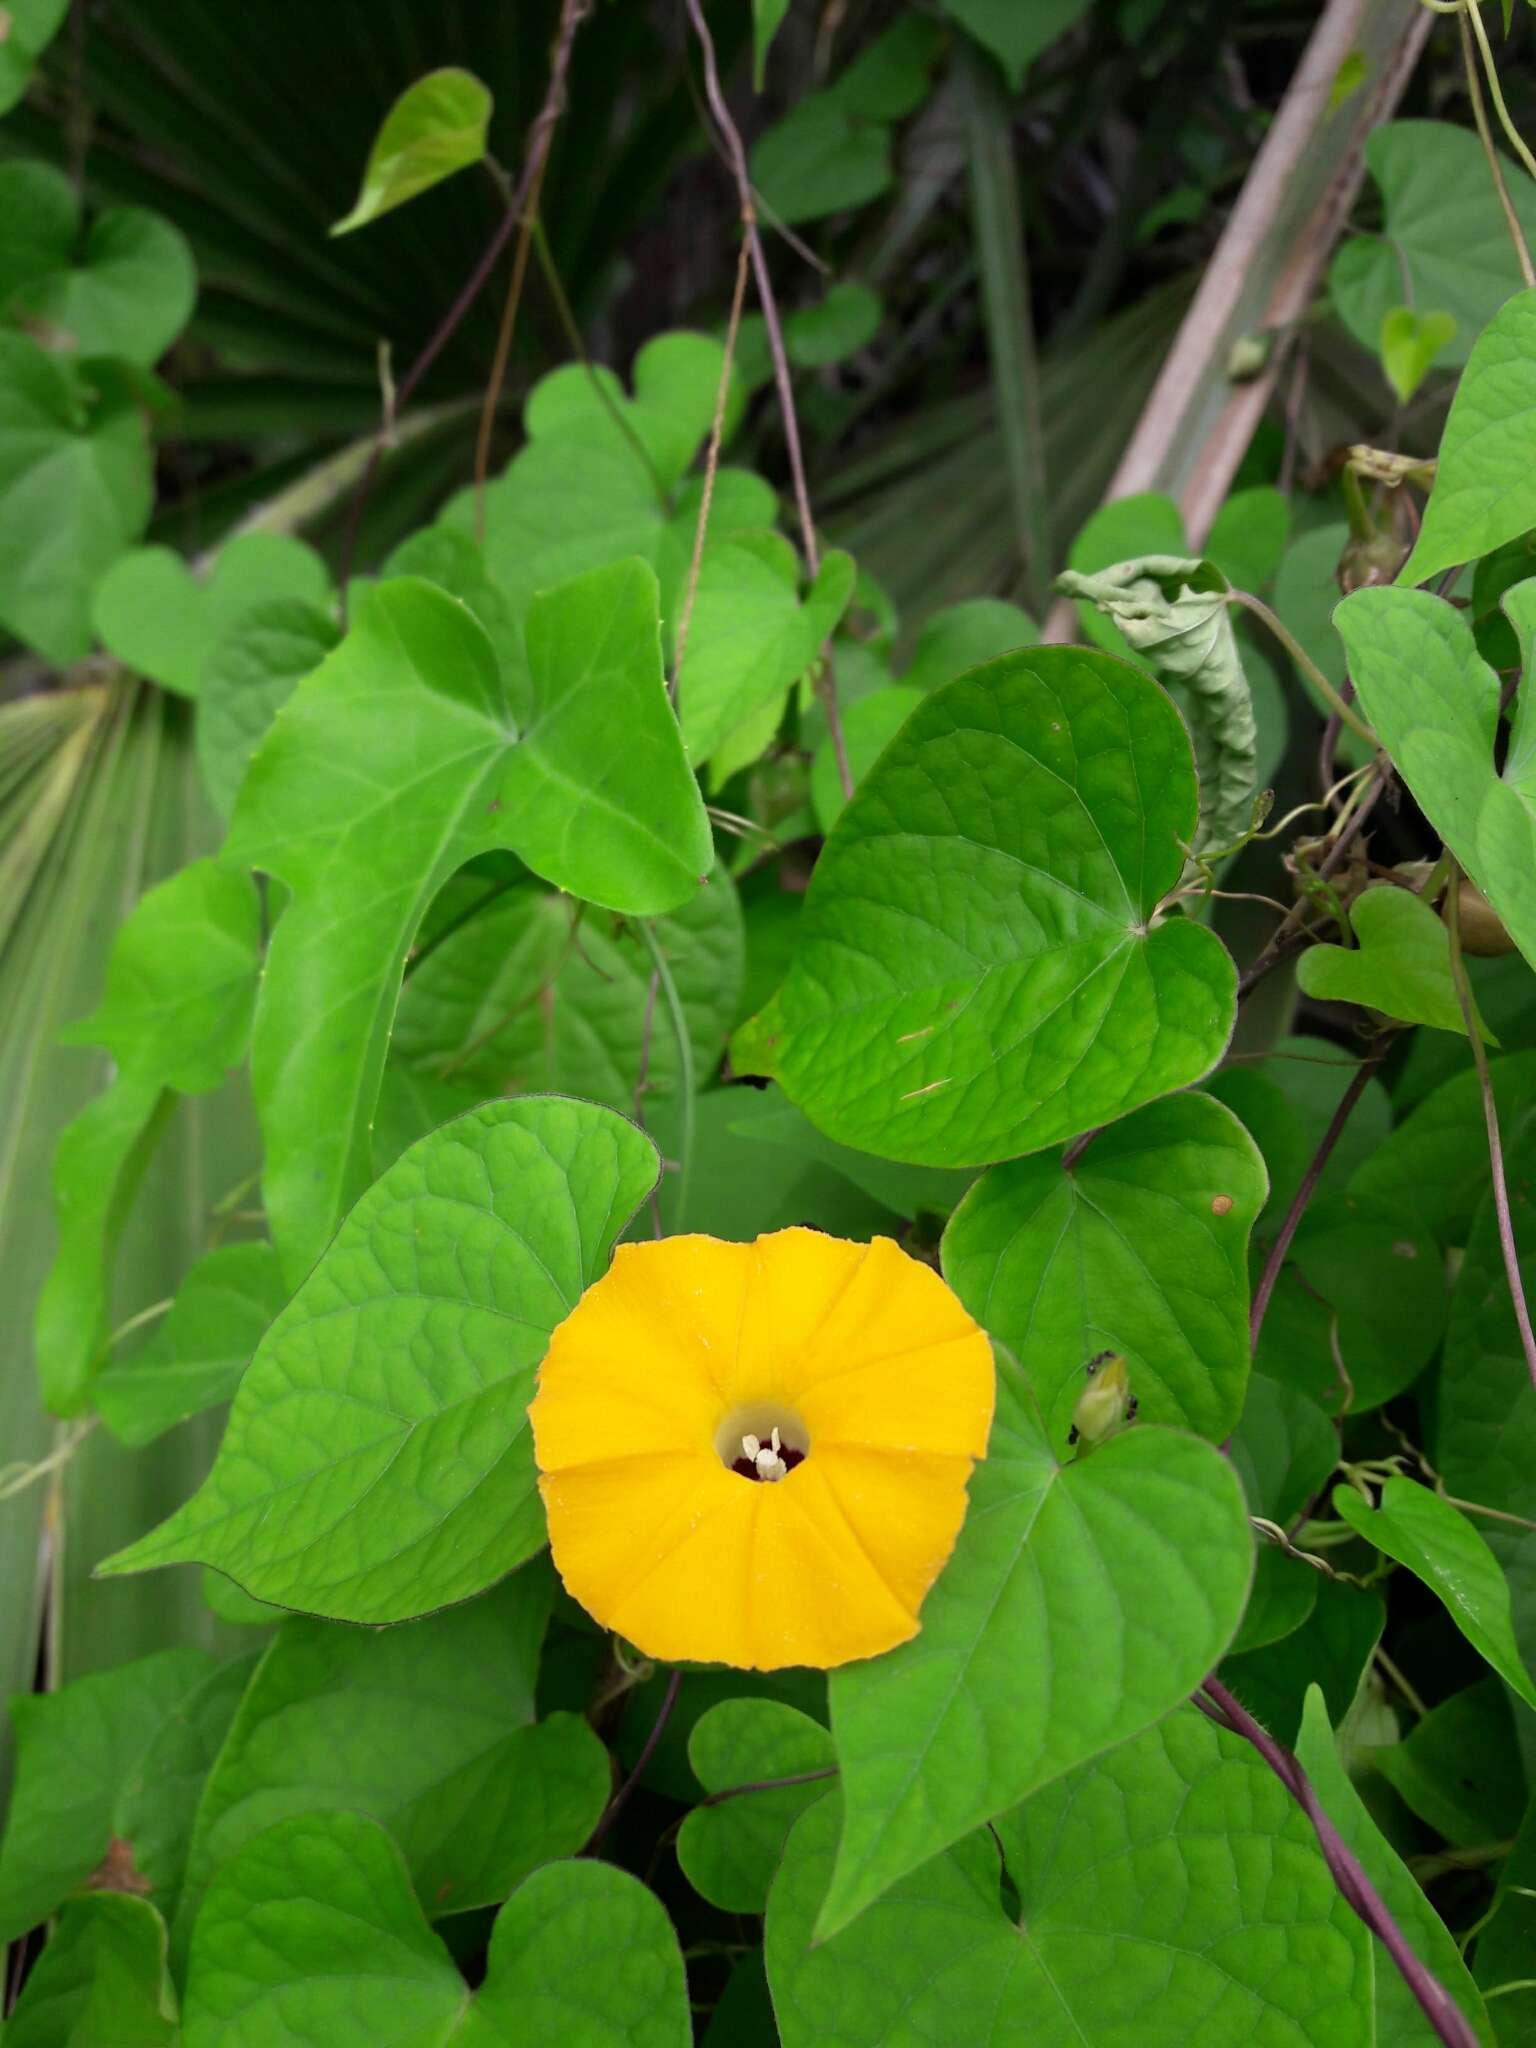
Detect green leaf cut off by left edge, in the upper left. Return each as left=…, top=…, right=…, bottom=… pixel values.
left=0, top=334, right=154, bottom=666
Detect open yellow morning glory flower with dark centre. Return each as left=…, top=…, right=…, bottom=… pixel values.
left=530, top=1229, right=993, bottom=1671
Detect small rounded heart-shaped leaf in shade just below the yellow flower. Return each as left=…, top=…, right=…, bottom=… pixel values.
left=678, top=1700, right=836, bottom=1913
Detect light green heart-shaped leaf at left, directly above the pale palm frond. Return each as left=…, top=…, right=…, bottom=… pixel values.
left=92, top=532, right=330, bottom=696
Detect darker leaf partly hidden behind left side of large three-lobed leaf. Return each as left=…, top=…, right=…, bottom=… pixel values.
left=197, top=598, right=342, bottom=817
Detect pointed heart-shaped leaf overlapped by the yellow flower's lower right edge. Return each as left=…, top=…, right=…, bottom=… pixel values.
left=817, top=1370, right=1253, bottom=1933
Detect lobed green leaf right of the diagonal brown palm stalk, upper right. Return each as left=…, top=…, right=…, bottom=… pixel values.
left=1327, top=121, right=1536, bottom=369
